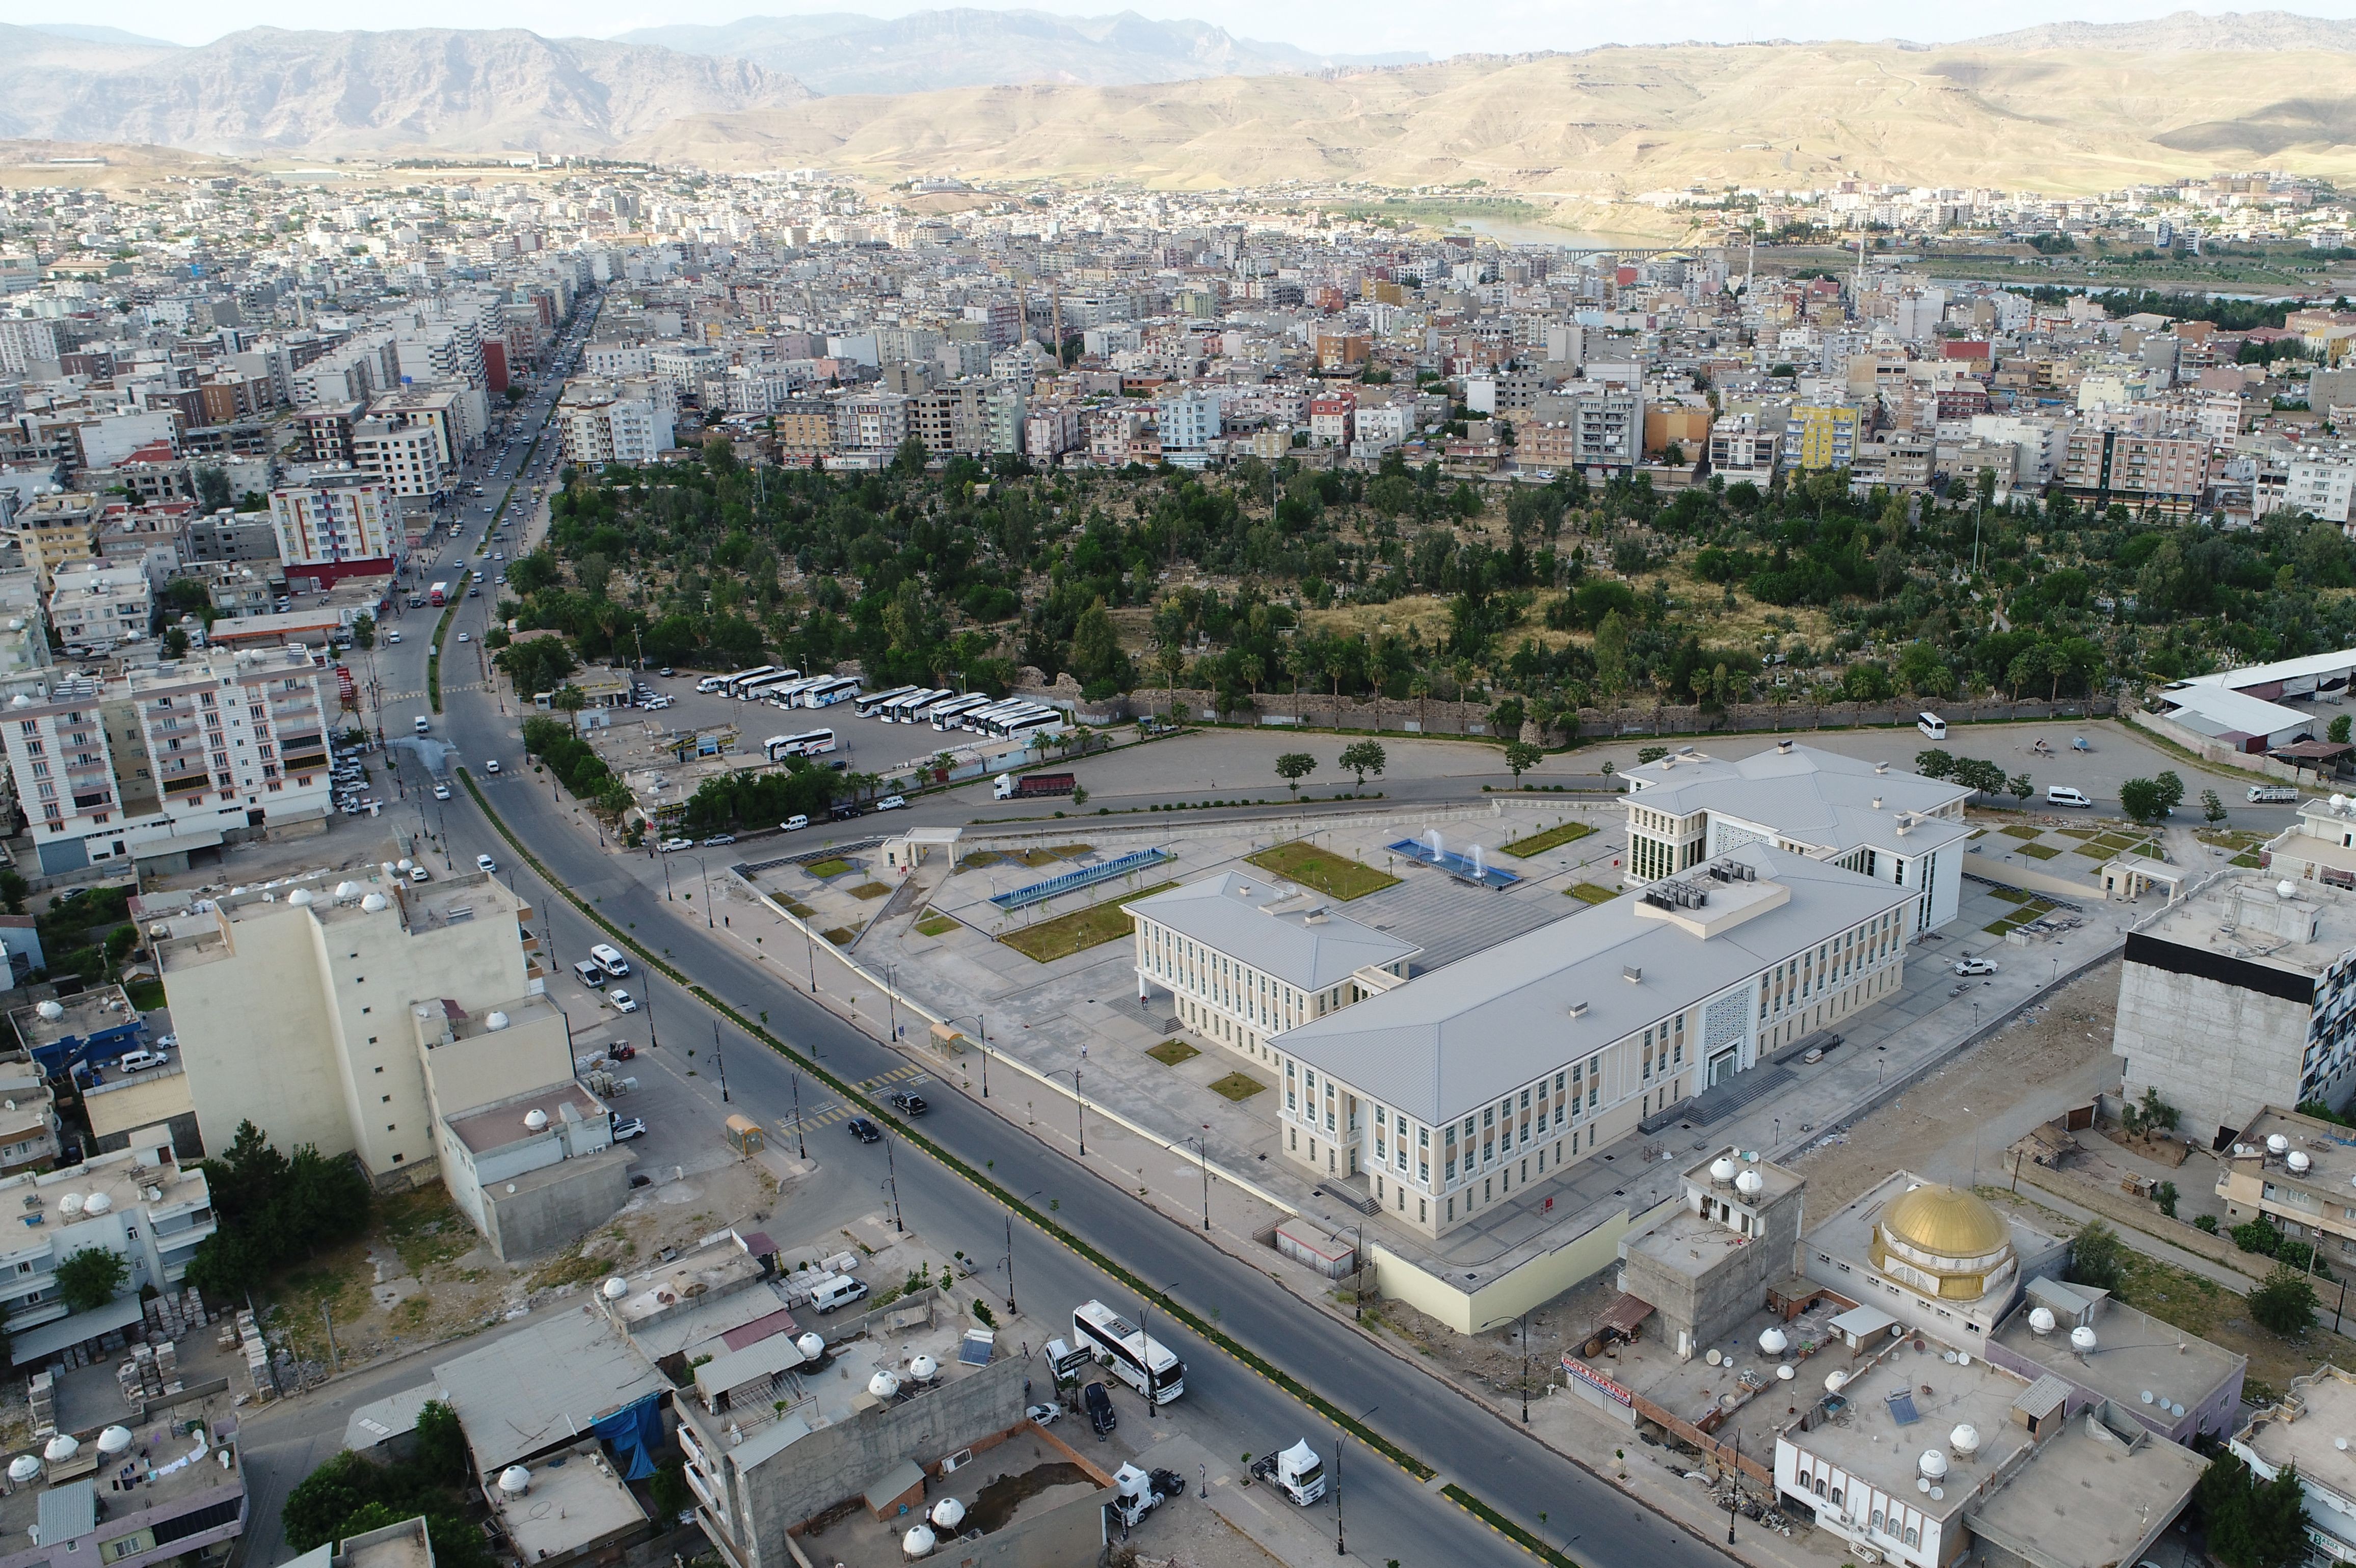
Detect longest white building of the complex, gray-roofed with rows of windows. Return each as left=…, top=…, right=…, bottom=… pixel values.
left=1272, top=843, right=1918, bottom=1236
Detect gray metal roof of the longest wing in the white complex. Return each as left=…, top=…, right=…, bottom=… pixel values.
left=1272, top=843, right=1918, bottom=1123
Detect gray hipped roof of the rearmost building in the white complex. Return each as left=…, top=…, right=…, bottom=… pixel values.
left=1626, top=746, right=1972, bottom=855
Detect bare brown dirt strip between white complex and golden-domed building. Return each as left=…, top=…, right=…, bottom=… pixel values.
left=1795, top=961, right=2118, bottom=1217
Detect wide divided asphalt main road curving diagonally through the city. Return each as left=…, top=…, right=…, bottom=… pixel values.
left=332, top=317, right=1727, bottom=1568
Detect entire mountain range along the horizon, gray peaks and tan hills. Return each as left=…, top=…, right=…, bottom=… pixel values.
left=14, top=9, right=2356, bottom=200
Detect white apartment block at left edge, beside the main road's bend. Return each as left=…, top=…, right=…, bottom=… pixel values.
left=0, top=647, right=330, bottom=876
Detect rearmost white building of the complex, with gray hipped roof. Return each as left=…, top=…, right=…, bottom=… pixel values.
left=1623, top=742, right=1972, bottom=932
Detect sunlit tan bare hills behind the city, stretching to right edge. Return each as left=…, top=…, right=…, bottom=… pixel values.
left=627, top=40, right=2356, bottom=196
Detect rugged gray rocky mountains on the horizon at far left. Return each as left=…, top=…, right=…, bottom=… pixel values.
left=0, top=26, right=808, bottom=153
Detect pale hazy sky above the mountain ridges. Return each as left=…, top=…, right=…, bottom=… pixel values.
left=49, top=0, right=2356, bottom=57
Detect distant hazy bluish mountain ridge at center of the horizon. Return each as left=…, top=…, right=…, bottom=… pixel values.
left=620, top=7, right=1423, bottom=94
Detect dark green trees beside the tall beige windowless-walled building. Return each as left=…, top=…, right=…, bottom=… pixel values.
left=189, top=1121, right=372, bottom=1302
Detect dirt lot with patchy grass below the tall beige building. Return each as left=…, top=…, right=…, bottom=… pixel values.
left=257, top=1163, right=778, bottom=1368
